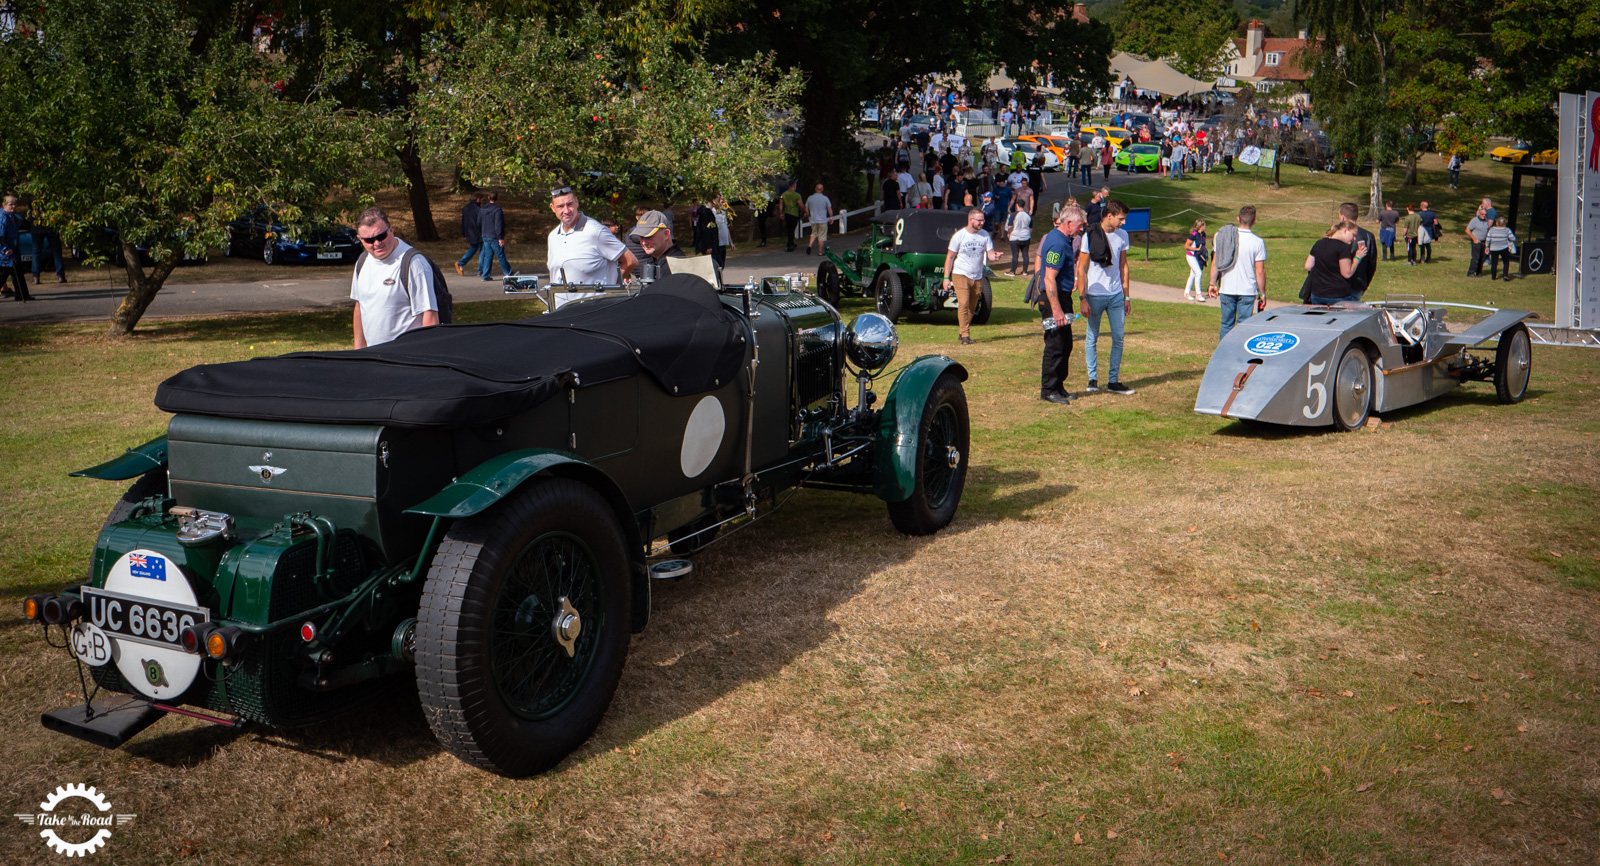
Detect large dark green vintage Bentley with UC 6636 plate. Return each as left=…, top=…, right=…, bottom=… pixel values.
left=26, top=274, right=968, bottom=776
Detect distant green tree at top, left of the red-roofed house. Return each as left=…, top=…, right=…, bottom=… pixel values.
left=1117, top=0, right=1238, bottom=80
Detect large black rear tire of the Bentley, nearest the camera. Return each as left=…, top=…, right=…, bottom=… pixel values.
left=416, top=479, right=632, bottom=778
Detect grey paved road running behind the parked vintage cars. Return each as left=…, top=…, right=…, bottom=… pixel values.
left=0, top=173, right=1164, bottom=325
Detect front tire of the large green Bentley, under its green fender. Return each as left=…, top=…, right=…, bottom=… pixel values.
left=888, top=371, right=971, bottom=535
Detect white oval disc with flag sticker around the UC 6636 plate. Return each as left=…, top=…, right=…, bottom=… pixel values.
left=103, top=549, right=200, bottom=701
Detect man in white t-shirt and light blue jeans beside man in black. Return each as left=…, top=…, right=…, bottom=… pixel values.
left=1077, top=198, right=1133, bottom=395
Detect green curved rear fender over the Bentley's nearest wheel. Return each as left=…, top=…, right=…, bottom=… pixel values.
left=406, top=448, right=650, bottom=634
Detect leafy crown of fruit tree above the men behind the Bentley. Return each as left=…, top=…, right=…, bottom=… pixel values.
left=418, top=16, right=800, bottom=212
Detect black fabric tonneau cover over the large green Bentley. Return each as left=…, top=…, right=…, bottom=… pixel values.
left=155, top=274, right=744, bottom=427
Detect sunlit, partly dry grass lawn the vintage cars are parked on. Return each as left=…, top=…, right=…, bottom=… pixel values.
left=0, top=192, right=1600, bottom=864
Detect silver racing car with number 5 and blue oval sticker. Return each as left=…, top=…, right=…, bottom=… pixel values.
left=1195, top=295, right=1534, bottom=431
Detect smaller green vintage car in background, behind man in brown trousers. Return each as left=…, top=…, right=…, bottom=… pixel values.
left=816, top=208, right=994, bottom=325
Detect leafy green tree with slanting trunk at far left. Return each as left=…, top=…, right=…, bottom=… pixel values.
left=0, top=0, right=392, bottom=336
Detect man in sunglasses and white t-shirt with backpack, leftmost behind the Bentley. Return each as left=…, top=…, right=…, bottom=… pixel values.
left=350, top=208, right=438, bottom=349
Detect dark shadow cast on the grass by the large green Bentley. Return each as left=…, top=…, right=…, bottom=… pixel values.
left=106, top=477, right=1056, bottom=773
